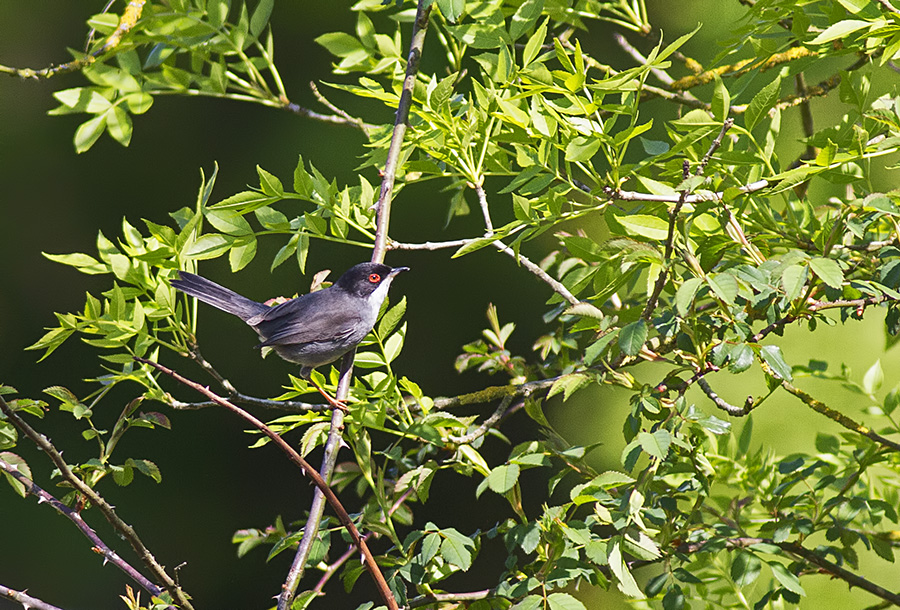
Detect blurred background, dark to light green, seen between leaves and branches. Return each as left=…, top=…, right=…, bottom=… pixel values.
left=0, top=0, right=900, bottom=610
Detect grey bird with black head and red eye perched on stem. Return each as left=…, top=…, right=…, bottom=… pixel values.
left=169, top=263, right=409, bottom=410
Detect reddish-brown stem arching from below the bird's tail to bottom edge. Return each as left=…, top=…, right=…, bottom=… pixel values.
left=134, top=356, right=398, bottom=610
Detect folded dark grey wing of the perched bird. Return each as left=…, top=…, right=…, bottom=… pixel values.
left=248, top=291, right=368, bottom=346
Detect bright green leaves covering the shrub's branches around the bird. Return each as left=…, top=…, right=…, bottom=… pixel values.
left=0, top=0, right=900, bottom=610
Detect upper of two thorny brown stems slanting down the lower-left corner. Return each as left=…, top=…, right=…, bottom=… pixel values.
left=0, top=396, right=193, bottom=610
